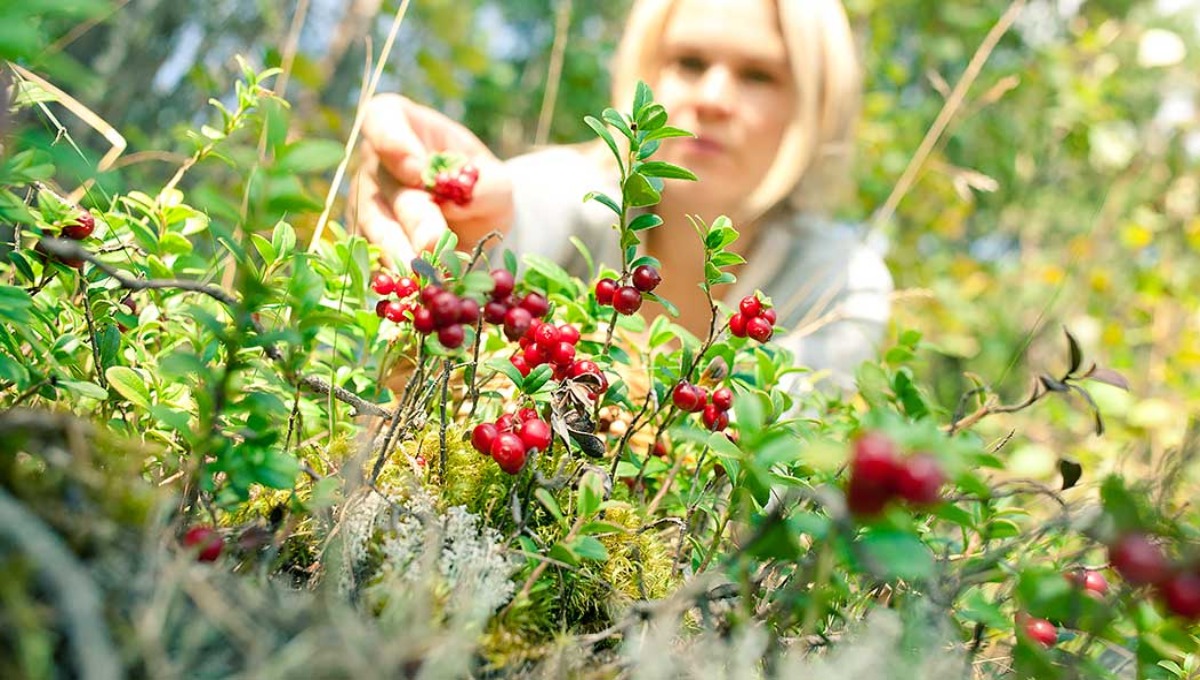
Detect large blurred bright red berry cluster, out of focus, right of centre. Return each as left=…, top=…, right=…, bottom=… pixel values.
left=846, top=432, right=946, bottom=517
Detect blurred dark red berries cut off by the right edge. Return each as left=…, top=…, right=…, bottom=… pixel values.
left=1109, top=532, right=1200, bottom=621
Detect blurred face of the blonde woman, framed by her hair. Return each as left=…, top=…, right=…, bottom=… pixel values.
left=654, top=0, right=796, bottom=217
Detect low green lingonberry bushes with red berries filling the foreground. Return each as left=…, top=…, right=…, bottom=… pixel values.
left=0, top=62, right=1200, bottom=678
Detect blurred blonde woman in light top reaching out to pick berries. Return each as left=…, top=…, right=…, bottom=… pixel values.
left=354, top=0, right=892, bottom=385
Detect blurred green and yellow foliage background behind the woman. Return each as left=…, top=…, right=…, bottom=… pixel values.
left=9, top=0, right=1200, bottom=491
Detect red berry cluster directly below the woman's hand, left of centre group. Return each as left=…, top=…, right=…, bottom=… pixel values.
left=371, top=272, right=480, bottom=349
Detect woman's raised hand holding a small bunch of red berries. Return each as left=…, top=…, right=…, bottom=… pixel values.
left=350, top=95, right=512, bottom=263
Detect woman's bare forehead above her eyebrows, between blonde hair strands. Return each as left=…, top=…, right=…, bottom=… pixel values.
left=662, top=0, right=787, bottom=61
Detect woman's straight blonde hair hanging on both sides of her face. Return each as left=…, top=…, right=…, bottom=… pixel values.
left=612, top=0, right=862, bottom=218
